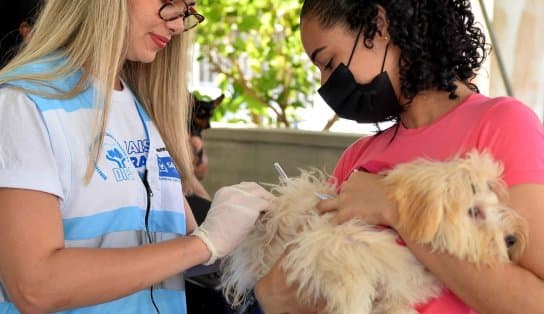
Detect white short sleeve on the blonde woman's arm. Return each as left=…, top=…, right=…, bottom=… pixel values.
left=0, top=87, right=63, bottom=198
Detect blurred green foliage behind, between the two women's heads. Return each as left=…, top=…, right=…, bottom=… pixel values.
left=196, top=0, right=318, bottom=127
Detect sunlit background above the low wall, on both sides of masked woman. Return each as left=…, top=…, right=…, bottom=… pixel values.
left=193, top=0, right=544, bottom=134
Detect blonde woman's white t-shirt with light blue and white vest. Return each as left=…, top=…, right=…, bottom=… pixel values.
left=0, top=77, right=186, bottom=313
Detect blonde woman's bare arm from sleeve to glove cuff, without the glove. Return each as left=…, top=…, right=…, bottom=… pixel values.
left=0, top=189, right=210, bottom=313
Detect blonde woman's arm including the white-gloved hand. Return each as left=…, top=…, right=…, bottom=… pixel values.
left=0, top=182, right=272, bottom=313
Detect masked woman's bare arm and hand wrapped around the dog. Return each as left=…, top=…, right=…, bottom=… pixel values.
left=318, top=172, right=544, bottom=314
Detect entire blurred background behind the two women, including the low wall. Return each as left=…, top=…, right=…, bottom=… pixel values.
left=0, top=0, right=544, bottom=194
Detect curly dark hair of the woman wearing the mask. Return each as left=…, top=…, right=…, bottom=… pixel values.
left=301, top=0, right=488, bottom=102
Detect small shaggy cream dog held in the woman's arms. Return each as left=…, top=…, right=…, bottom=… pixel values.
left=221, top=152, right=526, bottom=314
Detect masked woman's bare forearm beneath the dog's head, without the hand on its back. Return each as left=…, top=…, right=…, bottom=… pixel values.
left=407, top=241, right=544, bottom=314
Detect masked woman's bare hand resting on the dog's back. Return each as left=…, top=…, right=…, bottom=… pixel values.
left=317, top=171, right=398, bottom=228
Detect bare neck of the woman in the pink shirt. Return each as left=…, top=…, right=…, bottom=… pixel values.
left=400, top=83, right=473, bottom=129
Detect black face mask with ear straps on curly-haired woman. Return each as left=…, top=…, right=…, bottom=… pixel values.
left=318, top=31, right=403, bottom=123
